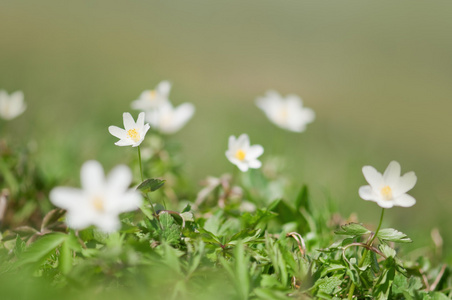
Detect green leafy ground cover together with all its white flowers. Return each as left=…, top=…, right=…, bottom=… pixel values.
left=0, top=81, right=452, bottom=299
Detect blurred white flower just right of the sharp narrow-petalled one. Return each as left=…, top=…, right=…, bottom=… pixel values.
left=146, top=101, right=195, bottom=134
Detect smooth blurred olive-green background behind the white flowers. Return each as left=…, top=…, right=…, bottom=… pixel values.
left=0, top=0, right=452, bottom=249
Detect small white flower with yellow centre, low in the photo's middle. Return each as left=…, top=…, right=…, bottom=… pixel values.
left=226, top=133, right=264, bottom=172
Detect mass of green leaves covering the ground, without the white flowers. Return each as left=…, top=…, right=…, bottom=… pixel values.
left=0, top=136, right=452, bottom=299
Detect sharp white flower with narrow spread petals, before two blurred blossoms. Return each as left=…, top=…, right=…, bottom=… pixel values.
left=108, top=112, right=149, bottom=147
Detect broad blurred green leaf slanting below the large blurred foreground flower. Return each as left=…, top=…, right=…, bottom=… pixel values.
left=16, top=233, right=68, bottom=267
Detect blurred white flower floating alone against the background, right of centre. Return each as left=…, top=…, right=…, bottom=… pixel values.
left=256, top=91, right=315, bottom=132
